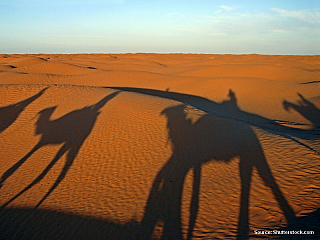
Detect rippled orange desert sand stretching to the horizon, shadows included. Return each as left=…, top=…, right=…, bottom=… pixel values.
left=0, top=53, right=320, bottom=239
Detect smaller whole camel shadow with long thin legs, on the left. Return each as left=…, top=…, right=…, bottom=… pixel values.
left=0, top=92, right=118, bottom=208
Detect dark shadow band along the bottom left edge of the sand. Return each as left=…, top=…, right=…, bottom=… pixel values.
left=0, top=208, right=139, bottom=240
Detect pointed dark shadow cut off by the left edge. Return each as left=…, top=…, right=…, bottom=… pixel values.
left=0, top=88, right=48, bottom=133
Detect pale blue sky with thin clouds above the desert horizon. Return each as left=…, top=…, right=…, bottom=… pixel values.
left=0, top=0, right=320, bottom=55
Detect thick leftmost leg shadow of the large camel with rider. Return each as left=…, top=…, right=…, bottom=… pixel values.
left=141, top=151, right=189, bottom=239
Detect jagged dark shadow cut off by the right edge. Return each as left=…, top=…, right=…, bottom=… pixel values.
left=283, top=93, right=320, bottom=127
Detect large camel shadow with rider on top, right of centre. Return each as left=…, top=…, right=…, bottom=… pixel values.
left=141, top=90, right=295, bottom=239
